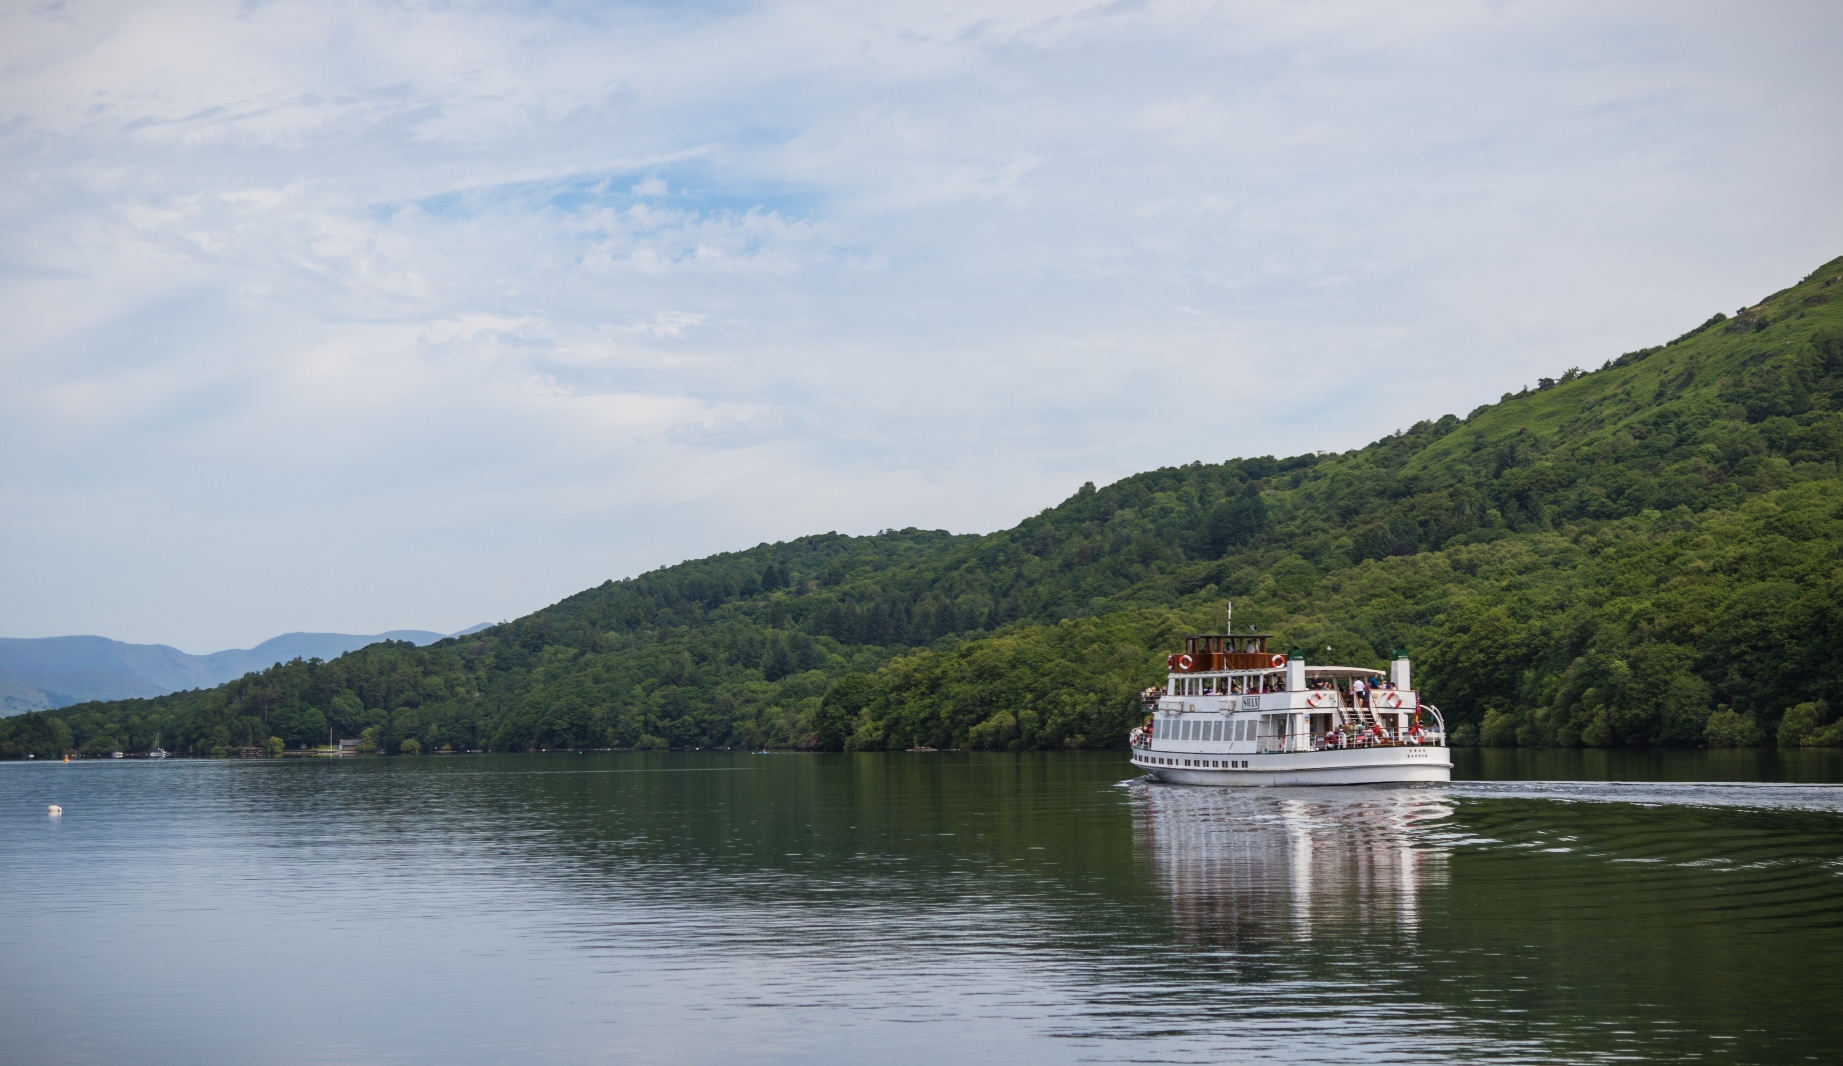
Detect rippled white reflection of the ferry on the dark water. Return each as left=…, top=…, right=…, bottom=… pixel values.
left=1135, top=784, right=1452, bottom=948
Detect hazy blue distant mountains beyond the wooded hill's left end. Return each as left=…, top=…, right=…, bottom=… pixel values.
left=0, top=623, right=490, bottom=716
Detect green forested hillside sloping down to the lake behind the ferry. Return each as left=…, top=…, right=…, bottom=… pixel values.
left=0, top=260, right=1843, bottom=754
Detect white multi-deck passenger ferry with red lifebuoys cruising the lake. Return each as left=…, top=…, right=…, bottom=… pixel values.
left=1132, top=616, right=1452, bottom=786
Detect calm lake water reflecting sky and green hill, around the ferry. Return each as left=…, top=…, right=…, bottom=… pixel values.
left=0, top=751, right=1843, bottom=1064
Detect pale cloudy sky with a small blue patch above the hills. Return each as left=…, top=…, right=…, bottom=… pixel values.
left=0, top=0, right=1843, bottom=651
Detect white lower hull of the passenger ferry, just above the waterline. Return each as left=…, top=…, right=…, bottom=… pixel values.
left=1133, top=745, right=1452, bottom=788
